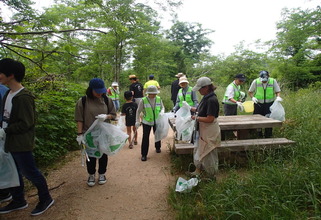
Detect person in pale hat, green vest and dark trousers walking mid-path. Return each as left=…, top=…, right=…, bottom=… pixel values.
left=135, top=85, right=165, bottom=161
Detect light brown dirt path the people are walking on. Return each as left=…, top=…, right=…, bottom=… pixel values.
left=0, top=128, right=175, bottom=220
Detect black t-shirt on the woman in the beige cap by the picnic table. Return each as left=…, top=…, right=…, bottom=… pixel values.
left=197, top=92, right=220, bottom=118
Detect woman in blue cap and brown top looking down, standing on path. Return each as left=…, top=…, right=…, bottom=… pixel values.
left=75, top=78, right=116, bottom=186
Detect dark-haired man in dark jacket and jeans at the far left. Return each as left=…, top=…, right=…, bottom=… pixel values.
left=0, top=58, right=54, bottom=215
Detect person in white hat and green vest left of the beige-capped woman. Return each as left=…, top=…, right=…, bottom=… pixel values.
left=173, top=76, right=198, bottom=112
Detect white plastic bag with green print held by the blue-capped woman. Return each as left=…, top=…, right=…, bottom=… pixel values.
left=84, top=120, right=128, bottom=158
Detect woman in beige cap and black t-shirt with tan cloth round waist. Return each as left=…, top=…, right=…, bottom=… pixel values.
left=191, top=77, right=221, bottom=175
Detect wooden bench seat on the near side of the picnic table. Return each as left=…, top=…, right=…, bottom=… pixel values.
left=174, top=138, right=295, bottom=154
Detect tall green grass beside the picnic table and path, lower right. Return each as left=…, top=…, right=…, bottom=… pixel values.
left=169, top=89, right=321, bottom=219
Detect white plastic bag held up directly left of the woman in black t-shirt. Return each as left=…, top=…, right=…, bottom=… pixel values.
left=175, top=101, right=195, bottom=141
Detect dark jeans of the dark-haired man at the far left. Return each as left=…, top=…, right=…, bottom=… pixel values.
left=9, top=151, right=51, bottom=202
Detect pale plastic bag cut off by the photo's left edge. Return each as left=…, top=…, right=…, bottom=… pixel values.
left=0, top=140, right=20, bottom=189
